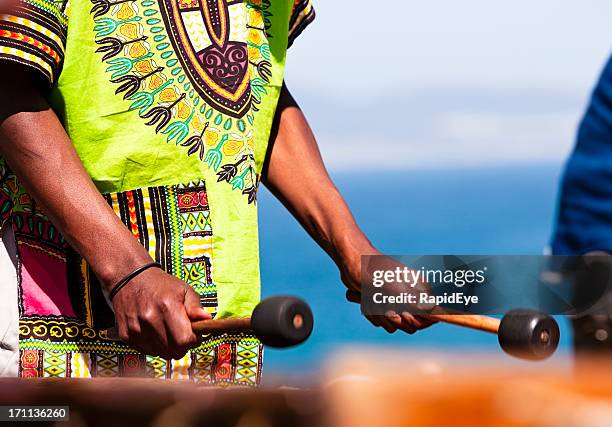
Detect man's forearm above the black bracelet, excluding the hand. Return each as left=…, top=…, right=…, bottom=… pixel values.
left=0, top=110, right=151, bottom=287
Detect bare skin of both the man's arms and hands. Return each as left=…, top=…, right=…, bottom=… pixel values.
left=0, top=82, right=429, bottom=359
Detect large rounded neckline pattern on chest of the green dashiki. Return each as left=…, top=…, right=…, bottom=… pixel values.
left=91, top=0, right=272, bottom=203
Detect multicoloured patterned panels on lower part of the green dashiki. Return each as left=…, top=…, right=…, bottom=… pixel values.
left=0, top=168, right=262, bottom=385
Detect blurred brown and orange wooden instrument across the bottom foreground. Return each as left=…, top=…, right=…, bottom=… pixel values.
left=0, top=349, right=612, bottom=427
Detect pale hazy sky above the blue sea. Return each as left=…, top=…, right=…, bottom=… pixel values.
left=285, top=0, right=612, bottom=171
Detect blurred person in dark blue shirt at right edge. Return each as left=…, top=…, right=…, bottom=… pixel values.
left=552, top=56, right=612, bottom=353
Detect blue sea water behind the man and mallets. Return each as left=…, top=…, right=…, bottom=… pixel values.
left=259, top=165, right=571, bottom=375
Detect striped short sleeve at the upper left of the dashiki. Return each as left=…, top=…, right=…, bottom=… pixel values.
left=0, top=0, right=68, bottom=85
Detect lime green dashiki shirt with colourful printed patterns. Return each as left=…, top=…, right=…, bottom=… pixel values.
left=0, top=0, right=314, bottom=385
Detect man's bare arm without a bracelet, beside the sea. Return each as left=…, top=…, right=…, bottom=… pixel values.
left=263, top=85, right=431, bottom=333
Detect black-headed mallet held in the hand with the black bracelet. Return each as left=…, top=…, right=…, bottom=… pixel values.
left=105, top=296, right=314, bottom=348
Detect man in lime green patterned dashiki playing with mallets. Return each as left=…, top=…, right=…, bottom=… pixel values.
left=0, top=0, right=426, bottom=385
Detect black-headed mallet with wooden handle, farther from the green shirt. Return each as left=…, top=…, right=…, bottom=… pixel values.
left=424, top=307, right=560, bottom=360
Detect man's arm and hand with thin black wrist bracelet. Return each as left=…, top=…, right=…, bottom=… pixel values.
left=0, top=75, right=210, bottom=358
